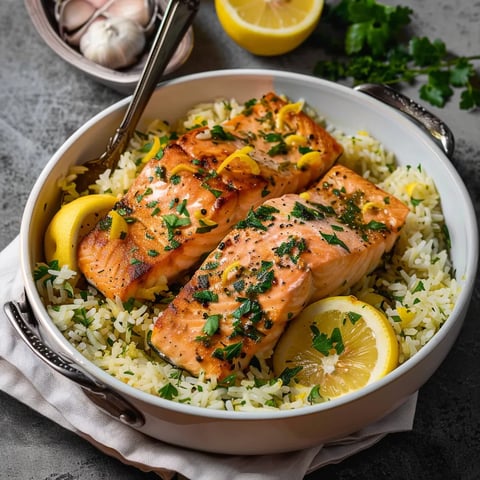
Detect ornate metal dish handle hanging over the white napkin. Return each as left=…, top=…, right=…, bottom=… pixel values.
left=4, top=299, right=145, bottom=427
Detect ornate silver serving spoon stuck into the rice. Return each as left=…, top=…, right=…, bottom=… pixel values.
left=75, top=0, right=200, bottom=193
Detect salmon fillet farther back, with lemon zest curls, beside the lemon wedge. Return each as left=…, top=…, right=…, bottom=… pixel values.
left=78, top=93, right=342, bottom=301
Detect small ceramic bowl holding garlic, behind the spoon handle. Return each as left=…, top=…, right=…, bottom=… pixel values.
left=25, top=0, right=193, bottom=94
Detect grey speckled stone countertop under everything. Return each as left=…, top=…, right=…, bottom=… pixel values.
left=0, top=0, right=480, bottom=480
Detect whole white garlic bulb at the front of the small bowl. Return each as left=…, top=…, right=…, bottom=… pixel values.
left=80, top=17, right=145, bottom=69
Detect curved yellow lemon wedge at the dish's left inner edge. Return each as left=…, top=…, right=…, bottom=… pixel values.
left=44, top=194, right=117, bottom=271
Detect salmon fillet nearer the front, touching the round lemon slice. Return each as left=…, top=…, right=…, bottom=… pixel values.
left=151, top=165, right=409, bottom=379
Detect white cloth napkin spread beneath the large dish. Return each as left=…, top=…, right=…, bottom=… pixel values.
left=0, top=238, right=417, bottom=480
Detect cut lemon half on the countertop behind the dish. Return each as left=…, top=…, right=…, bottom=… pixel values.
left=215, top=0, right=323, bottom=56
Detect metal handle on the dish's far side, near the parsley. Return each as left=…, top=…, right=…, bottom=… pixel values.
left=354, top=83, right=455, bottom=159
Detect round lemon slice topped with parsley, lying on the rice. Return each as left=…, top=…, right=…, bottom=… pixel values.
left=273, top=296, right=398, bottom=399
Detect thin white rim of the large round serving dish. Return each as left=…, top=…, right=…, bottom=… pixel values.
left=21, top=68, right=479, bottom=421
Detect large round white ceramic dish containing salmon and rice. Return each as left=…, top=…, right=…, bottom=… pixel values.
left=16, top=70, right=478, bottom=454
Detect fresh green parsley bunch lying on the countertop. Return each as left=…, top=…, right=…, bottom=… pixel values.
left=314, top=0, right=480, bottom=110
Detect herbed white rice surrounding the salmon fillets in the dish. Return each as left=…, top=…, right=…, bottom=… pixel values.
left=37, top=96, right=459, bottom=411
